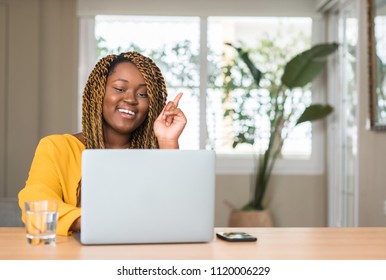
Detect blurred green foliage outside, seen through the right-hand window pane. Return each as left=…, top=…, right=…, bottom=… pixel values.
left=222, top=35, right=311, bottom=150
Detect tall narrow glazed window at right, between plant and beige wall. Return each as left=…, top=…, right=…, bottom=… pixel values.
left=326, top=0, right=360, bottom=227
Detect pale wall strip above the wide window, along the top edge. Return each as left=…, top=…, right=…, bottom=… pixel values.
left=77, top=0, right=318, bottom=16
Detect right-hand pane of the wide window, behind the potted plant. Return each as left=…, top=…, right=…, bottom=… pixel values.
left=207, top=17, right=312, bottom=158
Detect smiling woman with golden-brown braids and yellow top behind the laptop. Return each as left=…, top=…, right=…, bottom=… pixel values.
left=19, top=52, right=186, bottom=235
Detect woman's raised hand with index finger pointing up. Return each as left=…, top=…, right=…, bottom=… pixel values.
left=154, top=92, right=187, bottom=149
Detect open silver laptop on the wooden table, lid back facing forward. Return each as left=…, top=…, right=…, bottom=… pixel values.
left=80, top=149, right=215, bottom=244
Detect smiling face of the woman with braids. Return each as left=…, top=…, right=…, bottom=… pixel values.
left=103, top=62, right=149, bottom=135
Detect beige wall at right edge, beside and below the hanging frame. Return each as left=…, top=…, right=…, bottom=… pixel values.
left=358, top=1, right=386, bottom=226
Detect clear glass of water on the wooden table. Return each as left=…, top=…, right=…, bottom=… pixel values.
left=24, top=200, right=58, bottom=245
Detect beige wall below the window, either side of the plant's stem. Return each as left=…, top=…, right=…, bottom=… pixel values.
left=215, top=175, right=327, bottom=227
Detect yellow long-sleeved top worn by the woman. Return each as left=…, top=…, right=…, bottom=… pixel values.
left=19, top=134, right=85, bottom=235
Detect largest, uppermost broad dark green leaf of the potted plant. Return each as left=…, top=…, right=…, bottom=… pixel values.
left=281, top=43, right=339, bottom=89
